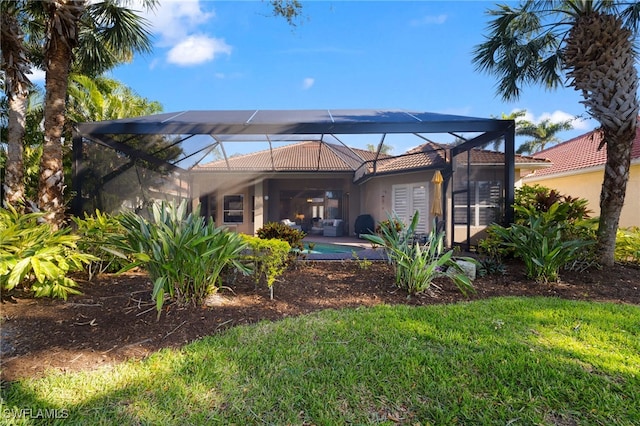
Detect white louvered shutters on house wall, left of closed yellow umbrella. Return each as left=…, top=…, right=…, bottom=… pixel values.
left=392, top=183, right=429, bottom=233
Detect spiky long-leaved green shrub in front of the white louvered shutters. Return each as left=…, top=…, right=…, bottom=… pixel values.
left=363, top=212, right=475, bottom=294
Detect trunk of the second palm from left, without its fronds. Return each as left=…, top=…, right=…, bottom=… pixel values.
left=38, top=0, right=85, bottom=227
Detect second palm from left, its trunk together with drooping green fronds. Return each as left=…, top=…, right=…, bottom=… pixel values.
left=38, top=0, right=157, bottom=226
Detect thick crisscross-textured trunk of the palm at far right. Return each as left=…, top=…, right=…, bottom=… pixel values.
left=564, top=12, right=639, bottom=266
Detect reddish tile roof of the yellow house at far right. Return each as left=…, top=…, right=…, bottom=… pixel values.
left=529, top=127, right=640, bottom=177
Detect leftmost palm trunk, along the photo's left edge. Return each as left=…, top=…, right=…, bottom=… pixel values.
left=0, top=0, right=31, bottom=207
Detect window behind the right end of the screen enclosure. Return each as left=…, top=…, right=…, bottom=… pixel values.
left=453, top=181, right=502, bottom=226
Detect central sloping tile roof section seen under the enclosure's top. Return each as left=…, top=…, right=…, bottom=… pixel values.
left=194, top=141, right=387, bottom=172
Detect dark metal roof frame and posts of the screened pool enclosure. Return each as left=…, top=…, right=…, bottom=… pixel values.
left=72, top=109, right=515, bottom=245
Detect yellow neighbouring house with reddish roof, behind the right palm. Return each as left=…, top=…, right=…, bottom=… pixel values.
left=522, top=129, right=640, bottom=228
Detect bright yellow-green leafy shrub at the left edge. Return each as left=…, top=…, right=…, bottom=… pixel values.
left=0, top=208, right=97, bottom=300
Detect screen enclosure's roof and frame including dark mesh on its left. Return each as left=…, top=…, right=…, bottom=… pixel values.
left=72, top=110, right=515, bottom=246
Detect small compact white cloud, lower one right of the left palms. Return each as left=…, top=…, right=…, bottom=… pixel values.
left=167, top=35, right=231, bottom=66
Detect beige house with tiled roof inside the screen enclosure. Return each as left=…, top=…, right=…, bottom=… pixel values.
left=192, top=141, right=549, bottom=243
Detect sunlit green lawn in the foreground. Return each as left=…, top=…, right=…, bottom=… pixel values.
left=0, top=298, right=640, bottom=425
